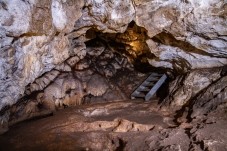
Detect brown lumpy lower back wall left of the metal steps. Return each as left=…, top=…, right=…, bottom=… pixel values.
left=0, top=37, right=151, bottom=133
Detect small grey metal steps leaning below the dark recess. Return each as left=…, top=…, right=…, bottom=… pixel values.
left=131, top=72, right=167, bottom=101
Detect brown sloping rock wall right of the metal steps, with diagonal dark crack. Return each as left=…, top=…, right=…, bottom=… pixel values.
left=160, top=66, right=227, bottom=133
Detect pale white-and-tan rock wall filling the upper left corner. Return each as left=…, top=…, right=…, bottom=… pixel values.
left=0, top=0, right=84, bottom=110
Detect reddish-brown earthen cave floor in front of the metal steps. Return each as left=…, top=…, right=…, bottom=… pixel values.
left=0, top=99, right=227, bottom=151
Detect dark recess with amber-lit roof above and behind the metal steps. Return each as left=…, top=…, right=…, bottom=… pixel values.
left=82, top=25, right=170, bottom=103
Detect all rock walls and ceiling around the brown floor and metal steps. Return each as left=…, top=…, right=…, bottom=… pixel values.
left=0, top=0, right=227, bottom=150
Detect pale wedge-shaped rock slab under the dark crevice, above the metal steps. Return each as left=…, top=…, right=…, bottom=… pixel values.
left=147, top=40, right=227, bottom=73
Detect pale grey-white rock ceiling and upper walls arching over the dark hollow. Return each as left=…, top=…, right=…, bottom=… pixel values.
left=0, top=0, right=227, bottom=134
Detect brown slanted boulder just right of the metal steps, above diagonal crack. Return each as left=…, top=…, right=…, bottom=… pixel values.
left=164, top=68, right=221, bottom=110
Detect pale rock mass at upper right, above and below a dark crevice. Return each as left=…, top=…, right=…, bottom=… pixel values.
left=135, top=0, right=227, bottom=72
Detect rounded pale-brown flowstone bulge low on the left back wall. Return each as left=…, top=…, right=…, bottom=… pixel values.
left=42, top=73, right=84, bottom=110
